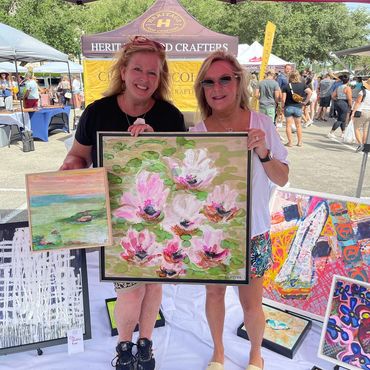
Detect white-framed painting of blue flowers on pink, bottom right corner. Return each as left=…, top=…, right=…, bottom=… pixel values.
left=318, top=275, right=370, bottom=370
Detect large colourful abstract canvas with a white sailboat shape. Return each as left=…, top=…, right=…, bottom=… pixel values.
left=264, top=190, right=370, bottom=320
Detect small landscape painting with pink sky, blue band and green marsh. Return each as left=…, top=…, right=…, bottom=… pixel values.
left=26, top=168, right=112, bottom=251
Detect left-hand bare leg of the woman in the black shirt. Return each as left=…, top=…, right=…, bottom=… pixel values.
left=114, top=285, right=145, bottom=342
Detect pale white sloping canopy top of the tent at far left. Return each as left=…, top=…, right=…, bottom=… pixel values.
left=0, top=23, right=68, bottom=62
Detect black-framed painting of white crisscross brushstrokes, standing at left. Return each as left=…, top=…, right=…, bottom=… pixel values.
left=0, top=222, right=91, bottom=354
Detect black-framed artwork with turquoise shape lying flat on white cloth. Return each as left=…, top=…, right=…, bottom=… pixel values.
left=237, top=304, right=312, bottom=358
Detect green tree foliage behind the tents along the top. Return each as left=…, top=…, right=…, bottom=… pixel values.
left=0, top=0, right=370, bottom=66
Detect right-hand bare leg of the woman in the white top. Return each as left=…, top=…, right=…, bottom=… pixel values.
left=239, top=278, right=265, bottom=368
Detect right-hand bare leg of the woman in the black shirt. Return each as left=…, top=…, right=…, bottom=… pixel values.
left=139, top=284, right=162, bottom=339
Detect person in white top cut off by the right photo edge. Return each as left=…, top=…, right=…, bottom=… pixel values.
left=351, top=78, right=370, bottom=152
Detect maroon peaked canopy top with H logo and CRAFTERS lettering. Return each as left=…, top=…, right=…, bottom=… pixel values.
left=82, top=0, right=238, bottom=59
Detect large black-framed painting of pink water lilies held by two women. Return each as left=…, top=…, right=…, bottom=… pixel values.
left=98, top=132, right=251, bottom=284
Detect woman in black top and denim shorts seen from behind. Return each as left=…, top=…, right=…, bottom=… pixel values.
left=282, top=71, right=312, bottom=147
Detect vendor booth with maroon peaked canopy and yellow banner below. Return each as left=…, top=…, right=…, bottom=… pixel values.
left=82, top=0, right=238, bottom=111
